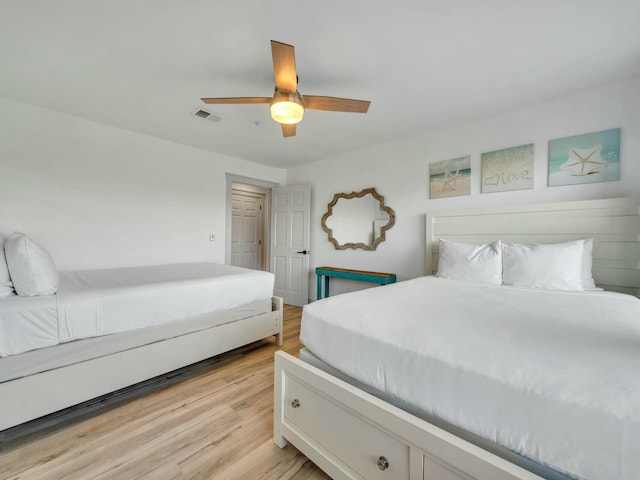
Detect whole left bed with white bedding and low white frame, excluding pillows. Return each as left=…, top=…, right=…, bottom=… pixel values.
left=0, top=263, right=282, bottom=430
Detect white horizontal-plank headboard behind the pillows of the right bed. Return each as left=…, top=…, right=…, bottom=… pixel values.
left=426, top=198, right=640, bottom=296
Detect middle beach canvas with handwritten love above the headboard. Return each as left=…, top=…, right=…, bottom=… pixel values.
left=481, top=143, right=534, bottom=193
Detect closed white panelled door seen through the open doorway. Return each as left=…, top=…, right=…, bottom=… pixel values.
left=231, top=190, right=264, bottom=270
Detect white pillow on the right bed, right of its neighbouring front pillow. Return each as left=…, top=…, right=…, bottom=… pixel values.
left=502, top=240, right=585, bottom=290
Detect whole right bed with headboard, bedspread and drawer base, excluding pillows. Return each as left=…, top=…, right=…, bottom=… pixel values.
left=274, top=199, right=640, bottom=480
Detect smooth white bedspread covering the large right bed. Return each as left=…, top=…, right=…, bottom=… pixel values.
left=300, top=277, right=640, bottom=480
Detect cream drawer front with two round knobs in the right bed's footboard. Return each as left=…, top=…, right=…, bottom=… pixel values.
left=284, top=378, right=409, bottom=480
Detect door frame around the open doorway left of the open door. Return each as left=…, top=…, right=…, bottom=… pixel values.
left=224, top=173, right=280, bottom=272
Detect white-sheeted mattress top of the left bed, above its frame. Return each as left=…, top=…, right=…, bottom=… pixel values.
left=0, top=263, right=274, bottom=357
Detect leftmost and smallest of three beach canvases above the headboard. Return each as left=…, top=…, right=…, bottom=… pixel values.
left=429, top=155, right=471, bottom=198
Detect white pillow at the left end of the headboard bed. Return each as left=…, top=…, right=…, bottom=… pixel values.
left=438, top=239, right=502, bottom=285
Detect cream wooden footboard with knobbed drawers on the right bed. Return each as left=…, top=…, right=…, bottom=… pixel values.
left=273, top=351, right=543, bottom=480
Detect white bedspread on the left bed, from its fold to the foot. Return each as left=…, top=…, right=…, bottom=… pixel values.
left=57, top=263, right=274, bottom=342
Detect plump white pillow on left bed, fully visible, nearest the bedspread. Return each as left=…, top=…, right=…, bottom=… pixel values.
left=4, top=232, right=58, bottom=297
